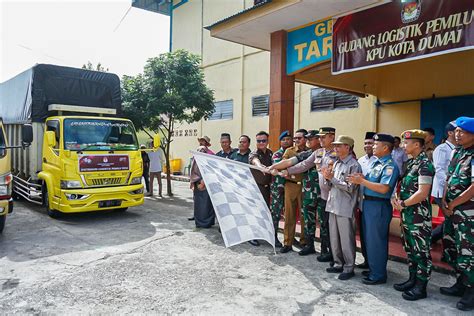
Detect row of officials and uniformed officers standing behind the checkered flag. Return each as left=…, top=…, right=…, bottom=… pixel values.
left=185, top=117, right=474, bottom=310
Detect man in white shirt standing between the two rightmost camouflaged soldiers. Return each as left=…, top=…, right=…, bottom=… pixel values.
left=431, top=121, right=456, bottom=244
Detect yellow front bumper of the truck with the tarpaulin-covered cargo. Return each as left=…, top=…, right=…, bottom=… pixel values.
left=51, top=184, right=144, bottom=213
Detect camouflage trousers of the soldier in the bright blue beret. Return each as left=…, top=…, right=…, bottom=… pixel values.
left=443, top=209, right=474, bottom=287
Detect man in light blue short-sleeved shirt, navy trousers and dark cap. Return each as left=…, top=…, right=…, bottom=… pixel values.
left=348, top=134, right=399, bottom=285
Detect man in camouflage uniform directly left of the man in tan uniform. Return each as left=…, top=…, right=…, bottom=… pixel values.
left=270, top=131, right=293, bottom=248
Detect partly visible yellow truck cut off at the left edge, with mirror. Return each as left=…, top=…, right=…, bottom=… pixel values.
left=0, top=117, right=33, bottom=234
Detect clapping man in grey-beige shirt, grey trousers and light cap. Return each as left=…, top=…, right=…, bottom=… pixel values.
left=322, top=135, right=362, bottom=280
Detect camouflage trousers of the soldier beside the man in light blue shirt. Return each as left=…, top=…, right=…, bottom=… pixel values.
left=401, top=205, right=433, bottom=281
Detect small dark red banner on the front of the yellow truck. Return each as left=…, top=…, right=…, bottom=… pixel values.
left=79, top=155, right=129, bottom=172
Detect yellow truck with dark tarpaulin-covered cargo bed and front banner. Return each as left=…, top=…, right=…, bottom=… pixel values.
left=0, top=64, right=144, bottom=217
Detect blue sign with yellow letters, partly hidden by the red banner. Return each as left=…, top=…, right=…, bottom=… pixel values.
left=286, top=18, right=332, bottom=75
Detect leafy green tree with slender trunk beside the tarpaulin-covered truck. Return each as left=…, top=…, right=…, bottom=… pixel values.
left=122, top=50, right=214, bottom=196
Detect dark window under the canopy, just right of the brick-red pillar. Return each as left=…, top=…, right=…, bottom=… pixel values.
left=311, top=88, right=359, bottom=111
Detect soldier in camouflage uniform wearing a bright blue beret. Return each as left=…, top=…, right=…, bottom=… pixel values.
left=440, top=117, right=474, bottom=311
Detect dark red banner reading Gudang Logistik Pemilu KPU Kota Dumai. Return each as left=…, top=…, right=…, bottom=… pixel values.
left=332, top=0, right=474, bottom=74
